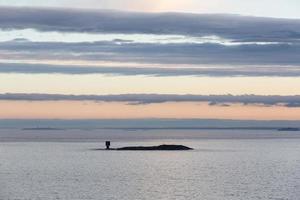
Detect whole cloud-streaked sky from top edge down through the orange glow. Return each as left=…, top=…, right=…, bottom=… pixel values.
left=0, top=0, right=300, bottom=120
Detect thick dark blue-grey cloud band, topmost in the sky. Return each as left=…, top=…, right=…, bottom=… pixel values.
left=0, top=7, right=300, bottom=41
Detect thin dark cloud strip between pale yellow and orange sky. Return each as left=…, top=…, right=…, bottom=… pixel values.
left=0, top=93, right=300, bottom=107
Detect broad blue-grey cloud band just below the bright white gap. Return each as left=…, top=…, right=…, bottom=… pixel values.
left=0, top=41, right=300, bottom=66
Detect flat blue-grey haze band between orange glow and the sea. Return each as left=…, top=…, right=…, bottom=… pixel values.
left=0, top=119, right=300, bottom=131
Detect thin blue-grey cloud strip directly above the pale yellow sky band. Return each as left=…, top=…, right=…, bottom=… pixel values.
left=0, top=63, right=300, bottom=77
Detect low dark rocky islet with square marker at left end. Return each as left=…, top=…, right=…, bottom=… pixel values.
left=99, top=141, right=193, bottom=151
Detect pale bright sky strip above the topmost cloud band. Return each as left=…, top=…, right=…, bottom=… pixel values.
left=0, top=0, right=300, bottom=18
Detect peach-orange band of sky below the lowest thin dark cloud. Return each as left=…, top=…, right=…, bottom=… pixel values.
left=0, top=101, right=300, bottom=120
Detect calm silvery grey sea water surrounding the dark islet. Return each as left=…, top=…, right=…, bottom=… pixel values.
left=0, top=130, right=300, bottom=200
